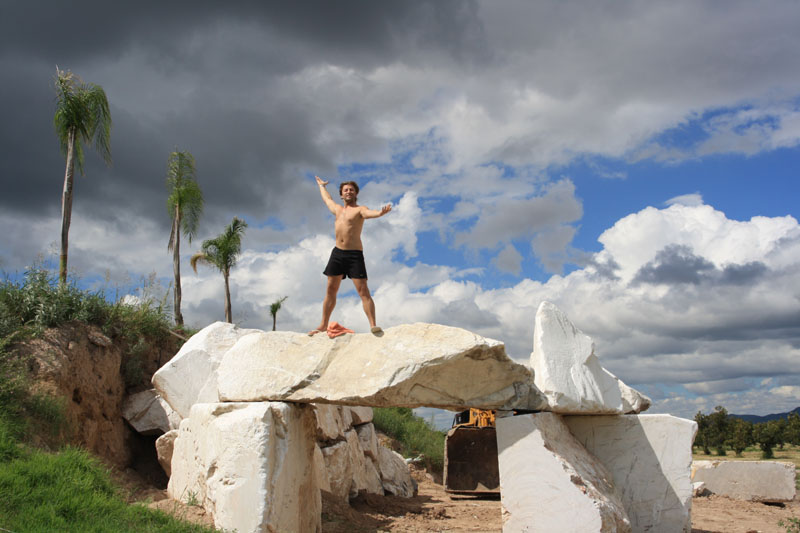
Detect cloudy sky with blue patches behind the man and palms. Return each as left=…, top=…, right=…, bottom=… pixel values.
left=0, top=1, right=800, bottom=426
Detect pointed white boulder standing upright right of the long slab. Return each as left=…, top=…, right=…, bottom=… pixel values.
left=530, top=302, right=650, bottom=414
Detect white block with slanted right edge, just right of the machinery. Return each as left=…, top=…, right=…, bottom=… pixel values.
left=496, top=413, right=631, bottom=533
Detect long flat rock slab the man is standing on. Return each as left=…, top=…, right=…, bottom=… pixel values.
left=217, top=323, right=546, bottom=410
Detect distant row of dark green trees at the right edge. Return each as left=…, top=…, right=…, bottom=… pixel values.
left=693, top=406, right=800, bottom=459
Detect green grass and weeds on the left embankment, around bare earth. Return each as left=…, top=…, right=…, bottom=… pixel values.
left=0, top=269, right=219, bottom=533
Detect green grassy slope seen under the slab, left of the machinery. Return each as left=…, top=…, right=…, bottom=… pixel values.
left=372, top=407, right=445, bottom=473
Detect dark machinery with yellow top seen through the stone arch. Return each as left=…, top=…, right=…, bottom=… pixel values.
left=444, top=409, right=500, bottom=494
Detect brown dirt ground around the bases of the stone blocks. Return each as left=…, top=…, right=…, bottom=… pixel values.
left=127, top=464, right=800, bottom=533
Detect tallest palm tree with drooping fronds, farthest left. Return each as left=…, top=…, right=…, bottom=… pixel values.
left=53, top=67, right=111, bottom=285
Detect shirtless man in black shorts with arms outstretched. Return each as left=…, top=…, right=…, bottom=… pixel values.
left=308, top=176, right=392, bottom=335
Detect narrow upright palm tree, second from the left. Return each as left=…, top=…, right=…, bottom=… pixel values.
left=167, top=151, right=203, bottom=326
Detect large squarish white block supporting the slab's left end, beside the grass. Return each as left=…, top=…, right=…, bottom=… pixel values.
left=167, top=402, right=322, bottom=533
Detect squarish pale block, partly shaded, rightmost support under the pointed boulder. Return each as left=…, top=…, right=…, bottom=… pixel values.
left=563, top=415, right=697, bottom=533
